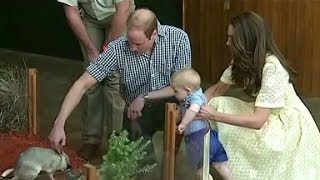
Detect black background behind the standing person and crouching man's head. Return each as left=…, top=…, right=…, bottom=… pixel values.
left=0, top=0, right=182, bottom=60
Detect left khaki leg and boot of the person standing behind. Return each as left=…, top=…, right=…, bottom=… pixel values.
left=78, top=16, right=105, bottom=159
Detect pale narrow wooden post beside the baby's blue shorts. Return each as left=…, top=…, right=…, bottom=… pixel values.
left=202, top=129, right=211, bottom=180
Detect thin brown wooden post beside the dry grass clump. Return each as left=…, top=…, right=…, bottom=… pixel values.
left=27, top=68, right=39, bottom=135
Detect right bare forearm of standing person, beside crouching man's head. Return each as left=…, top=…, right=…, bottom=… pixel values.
left=104, top=0, right=131, bottom=46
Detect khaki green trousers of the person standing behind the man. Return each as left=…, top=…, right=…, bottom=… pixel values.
left=80, top=14, right=124, bottom=145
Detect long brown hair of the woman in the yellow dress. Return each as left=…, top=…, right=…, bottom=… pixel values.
left=230, top=12, right=296, bottom=96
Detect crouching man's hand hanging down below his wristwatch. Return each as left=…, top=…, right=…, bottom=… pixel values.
left=127, top=95, right=145, bottom=120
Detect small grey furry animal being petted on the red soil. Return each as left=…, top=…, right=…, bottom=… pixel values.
left=2, top=147, right=71, bottom=180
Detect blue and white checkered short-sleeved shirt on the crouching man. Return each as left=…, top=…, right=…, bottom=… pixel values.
left=87, top=23, right=191, bottom=104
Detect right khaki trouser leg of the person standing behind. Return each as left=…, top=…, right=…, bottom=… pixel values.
left=103, top=16, right=125, bottom=135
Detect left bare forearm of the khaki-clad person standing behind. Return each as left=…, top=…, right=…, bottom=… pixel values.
left=63, top=5, right=99, bottom=60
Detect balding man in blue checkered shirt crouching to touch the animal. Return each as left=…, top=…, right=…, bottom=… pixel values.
left=49, top=9, right=191, bottom=166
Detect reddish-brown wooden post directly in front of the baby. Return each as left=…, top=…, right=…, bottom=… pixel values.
left=163, top=103, right=178, bottom=180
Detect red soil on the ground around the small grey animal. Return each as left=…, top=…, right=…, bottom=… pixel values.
left=0, top=132, right=85, bottom=172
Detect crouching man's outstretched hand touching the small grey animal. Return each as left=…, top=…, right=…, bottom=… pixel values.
left=49, top=125, right=66, bottom=154
